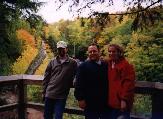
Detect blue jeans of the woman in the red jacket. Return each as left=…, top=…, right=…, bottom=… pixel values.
left=109, top=108, right=130, bottom=119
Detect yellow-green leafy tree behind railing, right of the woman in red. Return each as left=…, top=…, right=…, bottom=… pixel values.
left=126, top=30, right=163, bottom=82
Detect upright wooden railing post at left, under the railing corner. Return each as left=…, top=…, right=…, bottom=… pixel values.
left=18, top=79, right=27, bottom=119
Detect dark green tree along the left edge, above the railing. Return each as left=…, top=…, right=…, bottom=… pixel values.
left=0, top=0, right=42, bottom=75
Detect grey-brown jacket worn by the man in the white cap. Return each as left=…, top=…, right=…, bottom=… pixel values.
left=43, top=57, right=77, bottom=99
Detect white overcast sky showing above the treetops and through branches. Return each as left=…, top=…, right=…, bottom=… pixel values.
left=38, top=0, right=125, bottom=23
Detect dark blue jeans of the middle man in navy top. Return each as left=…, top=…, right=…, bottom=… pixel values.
left=84, top=110, right=109, bottom=119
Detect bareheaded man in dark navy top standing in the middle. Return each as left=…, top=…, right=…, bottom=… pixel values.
left=74, top=44, right=108, bottom=119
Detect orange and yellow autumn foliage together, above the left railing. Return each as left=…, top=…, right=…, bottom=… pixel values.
left=12, top=29, right=38, bottom=74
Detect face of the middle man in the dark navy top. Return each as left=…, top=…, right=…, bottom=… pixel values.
left=88, top=45, right=100, bottom=61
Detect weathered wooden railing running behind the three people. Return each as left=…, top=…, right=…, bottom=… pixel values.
left=0, top=75, right=163, bottom=119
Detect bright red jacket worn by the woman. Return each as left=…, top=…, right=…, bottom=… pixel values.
left=108, top=59, right=135, bottom=111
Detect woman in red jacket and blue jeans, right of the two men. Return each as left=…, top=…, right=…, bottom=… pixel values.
left=108, top=44, right=135, bottom=119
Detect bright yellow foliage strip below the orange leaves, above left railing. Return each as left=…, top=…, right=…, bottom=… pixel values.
left=12, top=45, right=38, bottom=74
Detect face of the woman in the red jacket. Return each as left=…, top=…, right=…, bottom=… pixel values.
left=108, top=46, right=118, bottom=60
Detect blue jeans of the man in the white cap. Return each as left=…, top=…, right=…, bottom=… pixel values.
left=44, top=97, right=66, bottom=119
